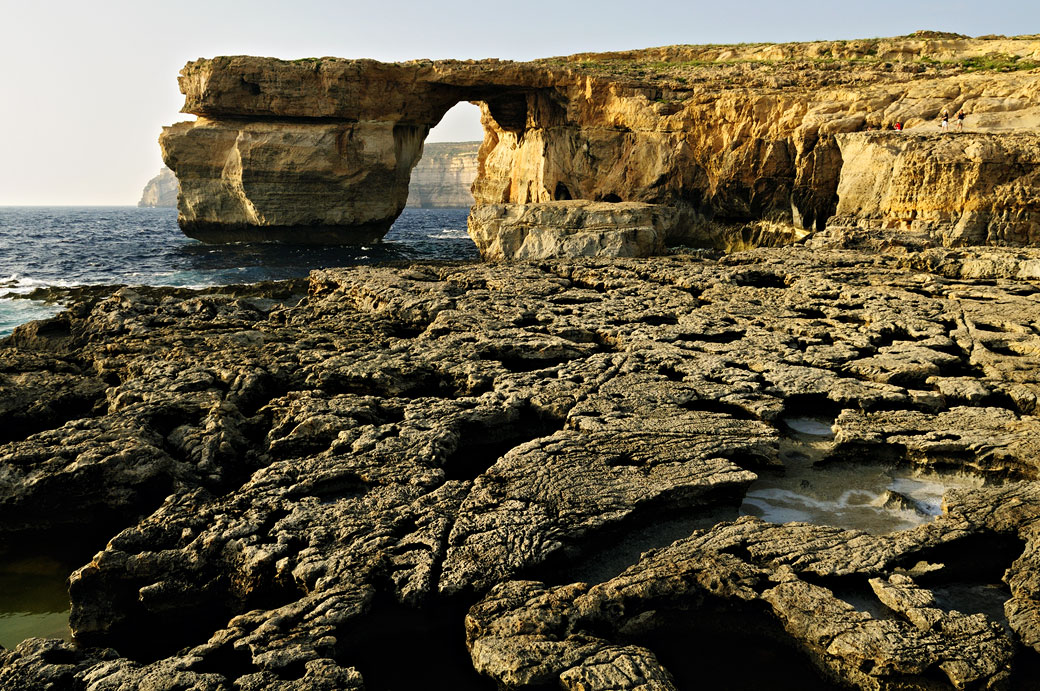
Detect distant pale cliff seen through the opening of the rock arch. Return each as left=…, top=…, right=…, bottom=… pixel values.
left=408, top=142, right=480, bottom=208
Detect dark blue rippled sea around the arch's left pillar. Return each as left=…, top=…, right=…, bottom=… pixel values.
left=0, top=206, right=479, bottom=336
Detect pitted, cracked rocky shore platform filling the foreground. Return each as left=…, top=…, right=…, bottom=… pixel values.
left=0, top=247, right=1040, bottom=691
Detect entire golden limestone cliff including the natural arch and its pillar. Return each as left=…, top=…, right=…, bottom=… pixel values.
left=160, top=33, right=1040, bottom=255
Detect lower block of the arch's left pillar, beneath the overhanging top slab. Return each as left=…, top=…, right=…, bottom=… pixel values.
left=162, top=119, right=425, bottom=244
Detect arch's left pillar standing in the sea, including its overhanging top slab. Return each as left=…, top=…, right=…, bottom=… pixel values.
left=160, top=57, right=549, bottom=244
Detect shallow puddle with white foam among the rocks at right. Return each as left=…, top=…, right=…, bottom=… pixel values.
left=740, top=417, right=983, bottom=534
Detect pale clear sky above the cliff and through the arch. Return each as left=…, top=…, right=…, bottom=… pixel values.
left=0, top=0, right=1040, bottom=205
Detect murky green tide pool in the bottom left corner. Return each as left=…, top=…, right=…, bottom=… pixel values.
left=0, top=557, right=71, bottom=649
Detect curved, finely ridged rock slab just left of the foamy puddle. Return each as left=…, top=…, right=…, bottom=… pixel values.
left=440, top=420, right=755, bottom=593
